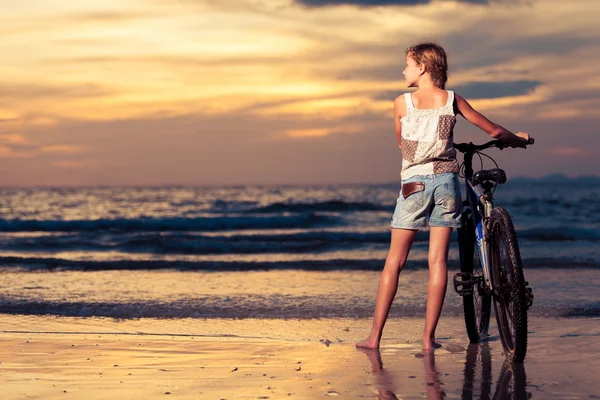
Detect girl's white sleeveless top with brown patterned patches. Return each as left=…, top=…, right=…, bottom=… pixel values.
left=400, top=90, right=459, bottom=180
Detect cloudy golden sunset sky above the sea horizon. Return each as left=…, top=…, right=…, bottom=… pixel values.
left=0, top=0, right=600, bottom=187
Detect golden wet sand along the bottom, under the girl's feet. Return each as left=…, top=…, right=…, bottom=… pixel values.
left=0, top=314, right=600, bottom=399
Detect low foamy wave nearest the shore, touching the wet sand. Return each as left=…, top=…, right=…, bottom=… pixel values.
left=0, top=295, right=600, bottom=319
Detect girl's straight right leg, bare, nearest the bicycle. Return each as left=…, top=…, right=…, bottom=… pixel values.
left=422, top=226, right=452, bottom=351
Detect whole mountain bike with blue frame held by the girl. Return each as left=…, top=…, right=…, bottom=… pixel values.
left=454, top=139, right=533, bottom=362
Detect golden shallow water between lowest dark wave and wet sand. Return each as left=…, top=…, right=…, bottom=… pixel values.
left=0, top=269, right=600, bottom=319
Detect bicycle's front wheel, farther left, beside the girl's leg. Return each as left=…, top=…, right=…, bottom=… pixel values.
left=458, top=208, right=492, bottom=343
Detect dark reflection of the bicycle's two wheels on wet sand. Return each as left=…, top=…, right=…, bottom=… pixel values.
left=461, top=342, right=529, bottom=400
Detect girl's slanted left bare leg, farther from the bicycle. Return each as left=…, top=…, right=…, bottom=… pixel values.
left=356, top=229, right=417, bottom=349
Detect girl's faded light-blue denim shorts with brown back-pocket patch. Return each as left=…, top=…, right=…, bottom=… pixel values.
left=391, top=172, right=462, bottom=229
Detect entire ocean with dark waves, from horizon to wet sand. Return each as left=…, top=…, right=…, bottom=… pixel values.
left=0, top=176, right=600, bottom=318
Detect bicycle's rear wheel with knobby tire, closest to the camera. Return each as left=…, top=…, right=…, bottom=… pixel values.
left=490, top=207, right=527, bottom=363
